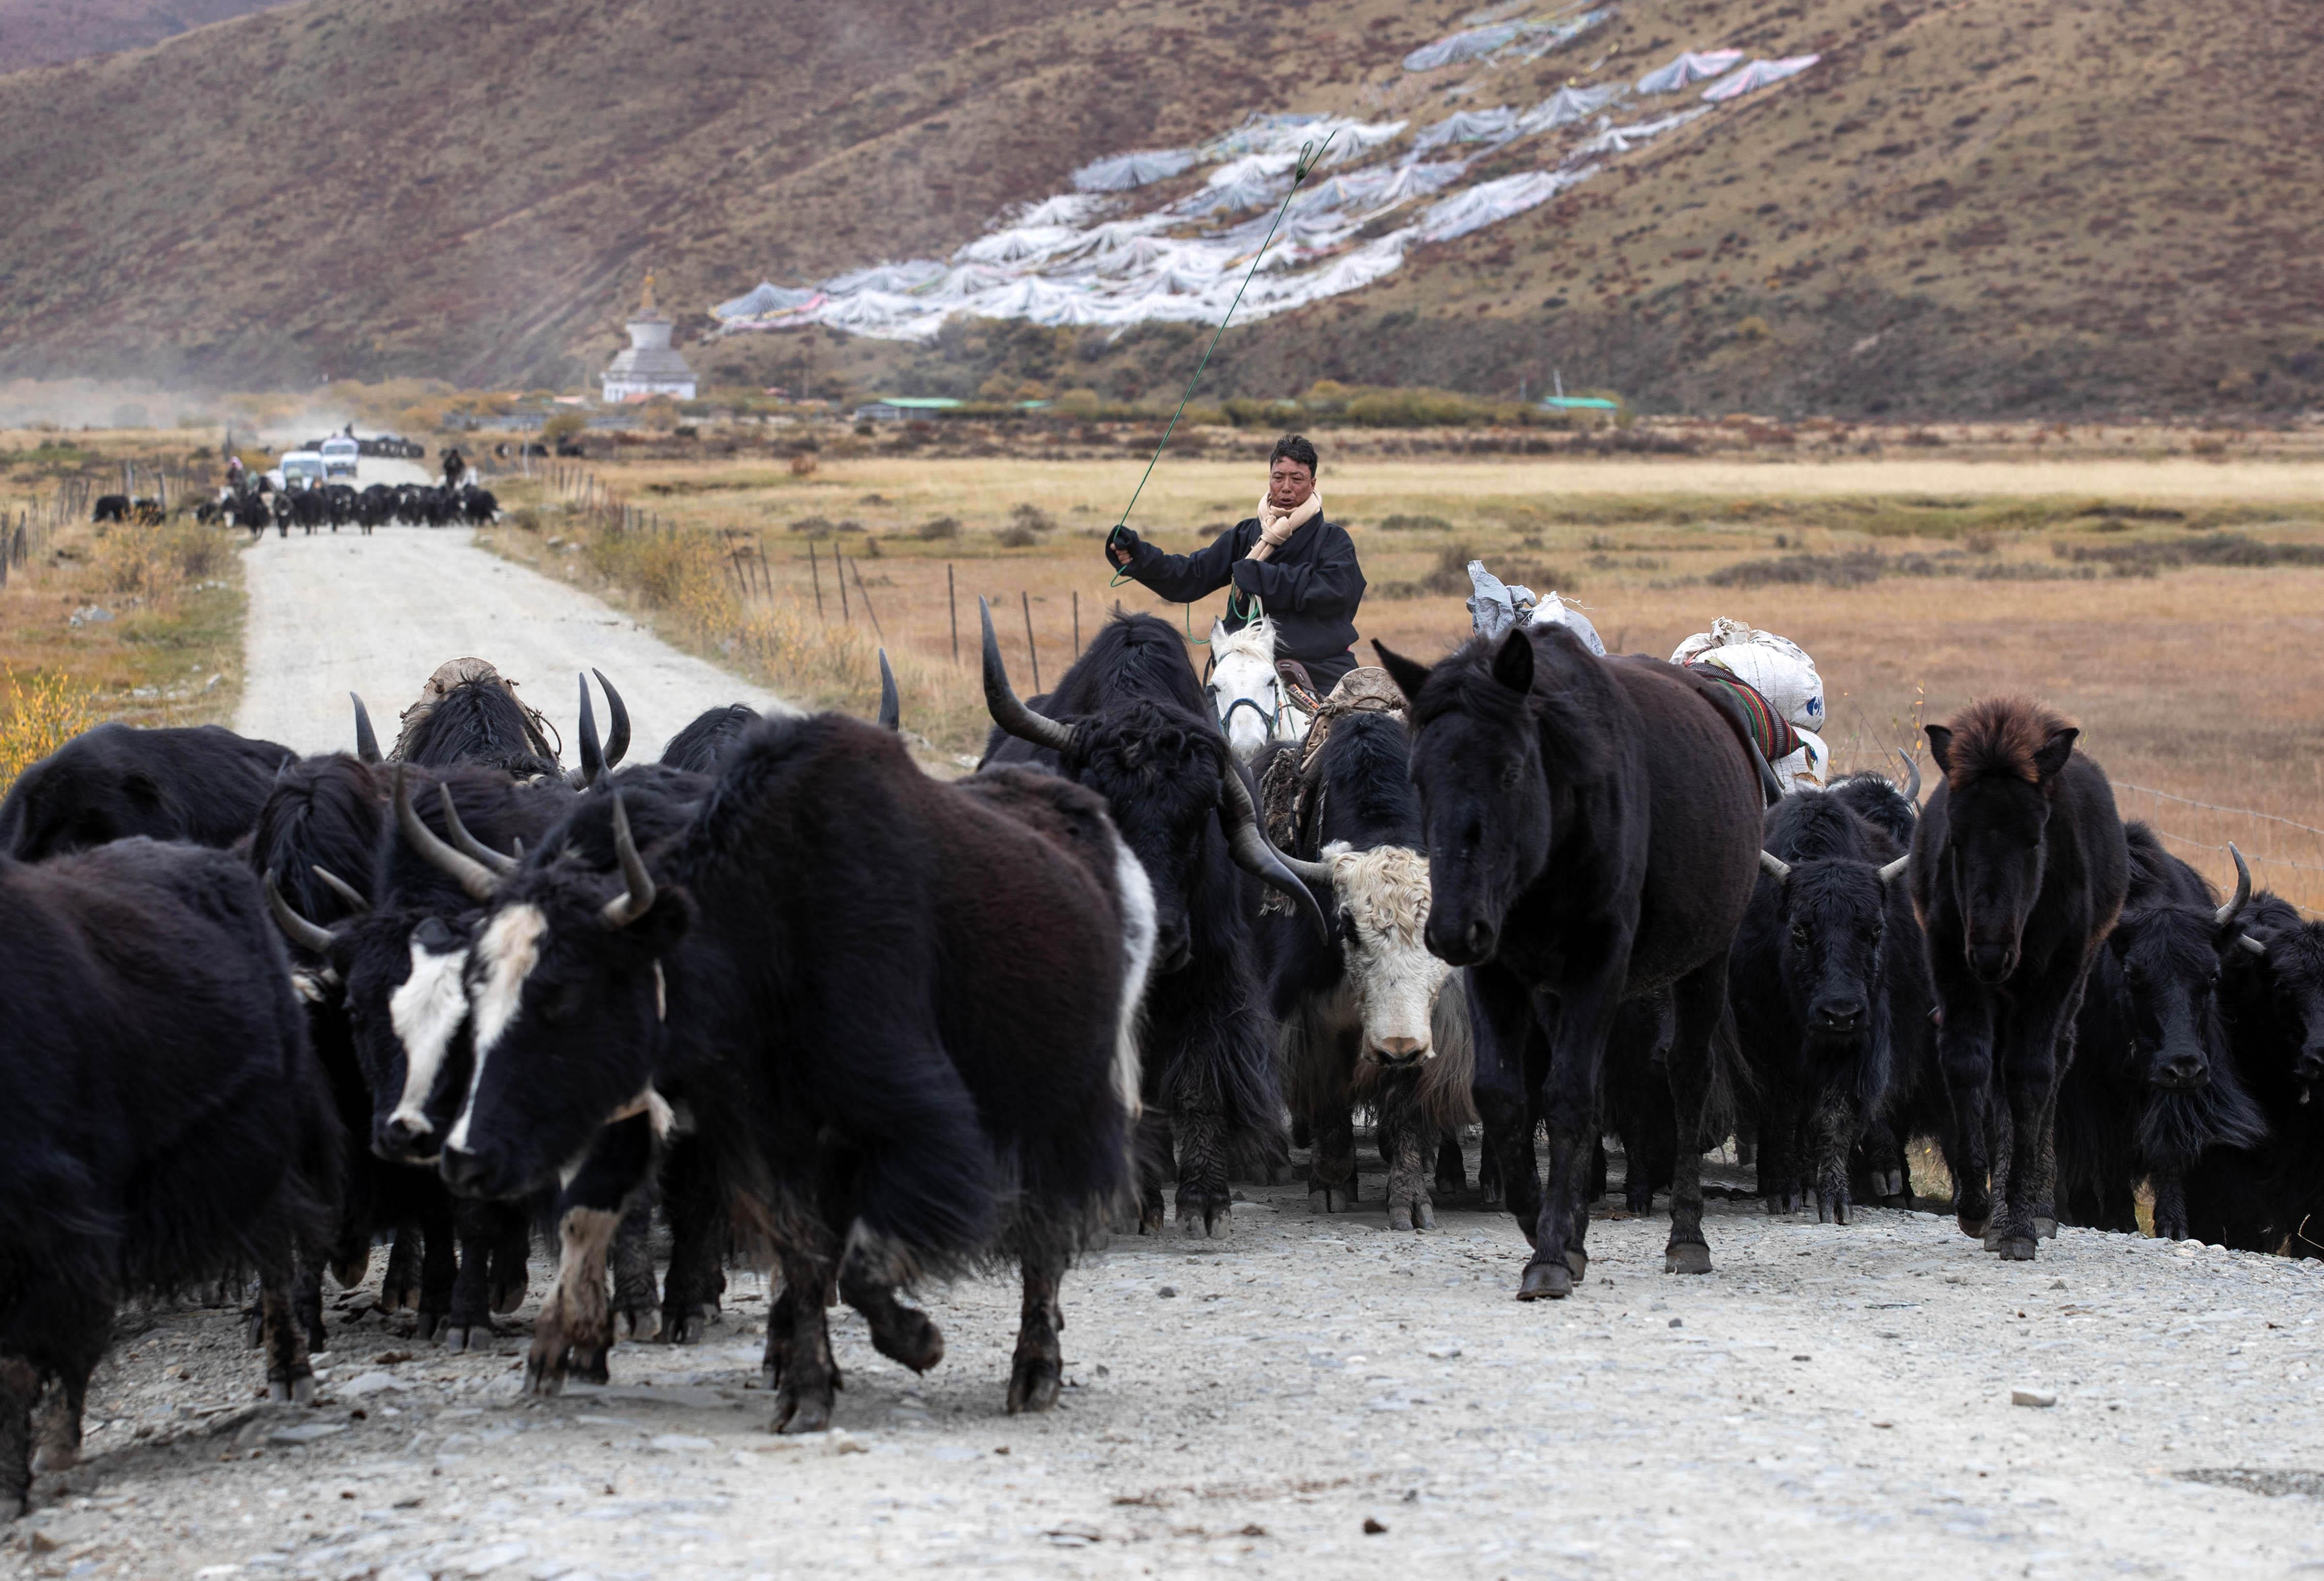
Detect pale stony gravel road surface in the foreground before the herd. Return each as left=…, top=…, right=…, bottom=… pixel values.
left=0, top=1148, right=2324, bottom=1581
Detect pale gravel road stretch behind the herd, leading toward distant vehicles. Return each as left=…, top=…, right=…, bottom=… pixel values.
left=235, top=461, right=774, bottom=763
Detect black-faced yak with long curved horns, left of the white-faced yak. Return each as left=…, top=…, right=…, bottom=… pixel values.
left=981, top=609, right=1325, bottom=1235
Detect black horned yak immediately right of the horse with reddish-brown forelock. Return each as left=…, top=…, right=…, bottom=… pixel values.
left=2057, top=823, right=2268, bottom=1242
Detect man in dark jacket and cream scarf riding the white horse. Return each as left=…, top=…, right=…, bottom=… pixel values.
left=1106, top=435, right=1364, bottom=698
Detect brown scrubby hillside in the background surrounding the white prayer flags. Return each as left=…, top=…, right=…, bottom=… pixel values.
left=0, top=0, right=2324, bottom=416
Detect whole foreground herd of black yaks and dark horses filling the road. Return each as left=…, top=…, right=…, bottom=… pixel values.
left=0, top=614, right=2324, bottom=1504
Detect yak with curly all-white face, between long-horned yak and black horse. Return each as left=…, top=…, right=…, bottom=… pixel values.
left=1262, top=714, right=1476, bottom=1230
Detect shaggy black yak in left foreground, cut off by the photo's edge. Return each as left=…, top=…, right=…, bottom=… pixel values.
left=0, top=840, right=339, bottom=1513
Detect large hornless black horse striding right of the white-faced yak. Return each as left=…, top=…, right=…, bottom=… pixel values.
left=1374, top=625, right=1766, bottom=1300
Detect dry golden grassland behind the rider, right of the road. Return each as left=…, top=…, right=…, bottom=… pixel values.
left=481, top=458, right=2324, bottom=909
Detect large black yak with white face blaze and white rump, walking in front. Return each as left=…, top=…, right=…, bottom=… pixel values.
left=442, top=714, right=1155, bottom=1432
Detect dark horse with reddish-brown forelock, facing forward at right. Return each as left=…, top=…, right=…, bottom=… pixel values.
left=1910, top=698, right=2129, bottom=1260
